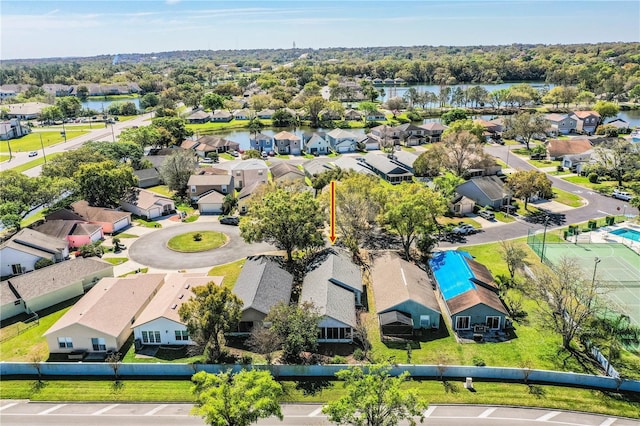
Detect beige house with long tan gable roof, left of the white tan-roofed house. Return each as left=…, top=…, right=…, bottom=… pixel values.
left=44, top=274, right=165, bottom=354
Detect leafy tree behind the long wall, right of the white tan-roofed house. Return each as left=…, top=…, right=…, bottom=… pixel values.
left=179, top=282, right=242, bottom=363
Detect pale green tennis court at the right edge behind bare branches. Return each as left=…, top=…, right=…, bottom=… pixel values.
left=532, top=243, right=640, bottom=326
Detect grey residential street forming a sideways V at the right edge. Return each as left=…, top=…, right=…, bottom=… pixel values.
left=439, top=145, right=638, bottom=248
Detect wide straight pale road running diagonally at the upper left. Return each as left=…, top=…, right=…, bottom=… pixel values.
left=0, top=113, right=153, bottom=176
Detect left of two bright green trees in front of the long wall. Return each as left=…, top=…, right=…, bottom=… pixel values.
left=191, top=370, right=283, bottom=426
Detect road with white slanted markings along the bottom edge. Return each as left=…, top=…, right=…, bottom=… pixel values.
left=0, top=400, right=640, bottom=426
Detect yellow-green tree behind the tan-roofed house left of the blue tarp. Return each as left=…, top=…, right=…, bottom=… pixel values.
left=380, top=182, right=446, bottom=259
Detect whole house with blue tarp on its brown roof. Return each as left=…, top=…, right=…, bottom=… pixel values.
left=429, top=250, right=507, bottom=333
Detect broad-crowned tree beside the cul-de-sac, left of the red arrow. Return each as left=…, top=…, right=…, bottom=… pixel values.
left=240, top=187, right=325, bottom=262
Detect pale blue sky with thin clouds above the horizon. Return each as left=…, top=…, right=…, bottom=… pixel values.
left=0, top=0, right=640, bottom=60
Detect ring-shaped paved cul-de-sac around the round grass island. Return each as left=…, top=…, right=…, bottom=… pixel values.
left=129, top=222, right=276, bottom=270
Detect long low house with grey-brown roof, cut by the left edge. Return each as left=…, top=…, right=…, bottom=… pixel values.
left=0, top=257, right=113, bottom=321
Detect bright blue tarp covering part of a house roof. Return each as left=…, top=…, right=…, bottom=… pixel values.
left=429, top=250, right=476, bottom=300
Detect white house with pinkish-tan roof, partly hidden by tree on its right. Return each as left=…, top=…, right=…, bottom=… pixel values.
left=130, top=273, right=223, bottom=345
